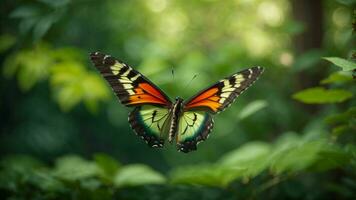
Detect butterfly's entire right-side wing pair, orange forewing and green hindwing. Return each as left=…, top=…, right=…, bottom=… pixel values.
left=176, top=67, right=263, bottom=153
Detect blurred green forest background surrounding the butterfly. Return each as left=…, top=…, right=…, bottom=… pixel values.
left=0, top=0, right=356, bottom=200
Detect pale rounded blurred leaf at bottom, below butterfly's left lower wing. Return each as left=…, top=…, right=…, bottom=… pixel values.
left=114, top=164, right=166, bottom=187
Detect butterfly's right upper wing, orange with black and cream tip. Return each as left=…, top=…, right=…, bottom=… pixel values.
left=185, top=67, right=263, bottom=114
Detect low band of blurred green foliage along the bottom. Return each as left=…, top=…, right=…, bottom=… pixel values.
left=0, top=132, right=356, bottom=199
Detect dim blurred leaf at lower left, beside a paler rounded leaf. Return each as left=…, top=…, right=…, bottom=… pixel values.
left=53, top=155, right=99, bottom=181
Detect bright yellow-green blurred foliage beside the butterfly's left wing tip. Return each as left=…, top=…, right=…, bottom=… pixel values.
left=3, top=43, right=109, bottom=111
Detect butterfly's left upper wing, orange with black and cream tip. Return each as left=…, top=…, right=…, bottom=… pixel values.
left=90, top=52, right=171, bottom=107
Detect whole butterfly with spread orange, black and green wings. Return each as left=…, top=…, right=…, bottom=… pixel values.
left=90, top=52, right=263, bottom=153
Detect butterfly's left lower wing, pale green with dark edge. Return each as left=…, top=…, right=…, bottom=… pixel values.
left=129, top=105, right=170, bottom=147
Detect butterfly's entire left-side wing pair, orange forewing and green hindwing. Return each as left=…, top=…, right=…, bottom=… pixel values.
left=90, top=52, right=172, bottom=147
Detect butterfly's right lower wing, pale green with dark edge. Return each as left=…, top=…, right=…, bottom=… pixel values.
left=176, top=111, right=214, bottom=153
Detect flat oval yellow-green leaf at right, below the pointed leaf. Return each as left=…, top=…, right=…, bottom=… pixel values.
left=293, top=87, right=352, bottom=104
